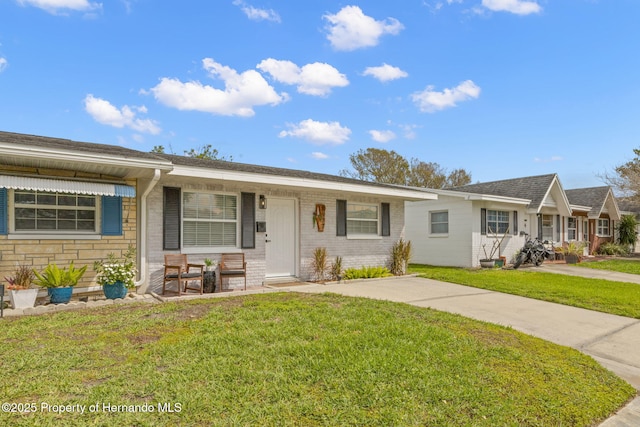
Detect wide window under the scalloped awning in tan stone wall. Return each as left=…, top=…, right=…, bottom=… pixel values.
left=13, top=190, right=96, bottom=232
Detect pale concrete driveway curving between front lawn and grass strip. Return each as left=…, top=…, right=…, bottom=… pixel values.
left=288, top=272, right=640, bottom=427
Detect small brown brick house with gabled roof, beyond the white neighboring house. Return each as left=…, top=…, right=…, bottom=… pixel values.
left=563, top=186, right=621, bottom=253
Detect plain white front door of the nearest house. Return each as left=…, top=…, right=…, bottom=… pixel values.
left=265, top=197, right=296, bottom=277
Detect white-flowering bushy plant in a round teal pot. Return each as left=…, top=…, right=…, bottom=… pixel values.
left=93, top=246, right=137, bottom=299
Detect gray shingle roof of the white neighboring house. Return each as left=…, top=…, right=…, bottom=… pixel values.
left=447, top=174, right=557, bottom=209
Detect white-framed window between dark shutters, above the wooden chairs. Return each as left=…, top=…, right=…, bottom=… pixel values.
left=182, top=192, right=238, bottom=247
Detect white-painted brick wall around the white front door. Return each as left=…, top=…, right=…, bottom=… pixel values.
left=145, top=176, right=404, bottom=292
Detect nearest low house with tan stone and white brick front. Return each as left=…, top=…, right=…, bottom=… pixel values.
left=0, top=132, right=437, bottom=292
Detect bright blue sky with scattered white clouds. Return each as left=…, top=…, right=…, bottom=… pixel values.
left=0, top=0, right=640, bottom=188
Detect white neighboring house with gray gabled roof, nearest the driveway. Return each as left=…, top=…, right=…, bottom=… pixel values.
left=405, top=174, right=572, bottom=267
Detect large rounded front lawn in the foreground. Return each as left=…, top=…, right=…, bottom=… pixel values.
left=0, top=293, right=635, bottom=426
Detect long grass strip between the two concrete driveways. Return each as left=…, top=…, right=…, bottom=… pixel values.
left=409, top=264, right=640, bottom=319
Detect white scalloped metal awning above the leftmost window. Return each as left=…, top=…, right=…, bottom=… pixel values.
left=0, top=175, right=136, bottom=197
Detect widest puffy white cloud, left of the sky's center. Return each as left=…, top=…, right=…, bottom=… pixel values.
left=151, top=58, right=288, bottom=117
